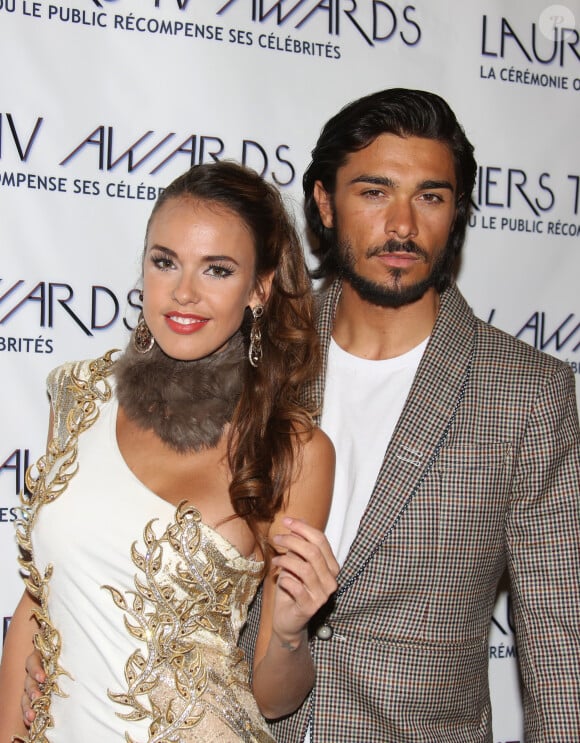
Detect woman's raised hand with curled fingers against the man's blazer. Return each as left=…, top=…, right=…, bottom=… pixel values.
left=272, top=516, right=339, bottom=649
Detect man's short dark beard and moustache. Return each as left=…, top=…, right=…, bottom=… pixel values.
left=335, top=240, right=452, bottom=307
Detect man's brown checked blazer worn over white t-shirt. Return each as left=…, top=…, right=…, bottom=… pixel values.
left=245, top=282, right=580, bottom=743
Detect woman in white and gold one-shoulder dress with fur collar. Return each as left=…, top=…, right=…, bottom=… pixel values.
left=0, top=162, right=338, bottom=743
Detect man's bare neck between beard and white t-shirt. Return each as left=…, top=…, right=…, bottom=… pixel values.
left=332, top=282, right=439, bottom=360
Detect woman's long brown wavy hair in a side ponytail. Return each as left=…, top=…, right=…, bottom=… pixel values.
left=143, top=161, right=320, bottom=556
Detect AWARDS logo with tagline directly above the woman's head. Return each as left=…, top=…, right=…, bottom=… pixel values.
left=0, top=112, right=296, bottom=189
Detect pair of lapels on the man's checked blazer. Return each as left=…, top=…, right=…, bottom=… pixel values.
left=321, top=285, right=475, bottom=595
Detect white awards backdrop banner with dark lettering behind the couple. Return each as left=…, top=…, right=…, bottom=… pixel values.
left=0, top=0, right=580, bottom=743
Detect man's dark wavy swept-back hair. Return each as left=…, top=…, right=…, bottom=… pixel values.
left=302, top=88, right=477, bottom=291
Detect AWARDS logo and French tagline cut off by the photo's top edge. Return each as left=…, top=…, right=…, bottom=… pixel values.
left=6, top=0, right=422, bottom=60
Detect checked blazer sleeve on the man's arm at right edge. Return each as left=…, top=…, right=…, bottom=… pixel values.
left=506, top=364, right=580, bottom=743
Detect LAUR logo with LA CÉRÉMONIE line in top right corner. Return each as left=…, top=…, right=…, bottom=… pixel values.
left=479, top=5, right=580, bottom=92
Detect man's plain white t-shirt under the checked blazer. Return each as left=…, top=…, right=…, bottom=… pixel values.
left=320, top=339, right=428, bottom=565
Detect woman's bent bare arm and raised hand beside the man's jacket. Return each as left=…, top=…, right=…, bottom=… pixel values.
left=252, top=429, right=338, bottom=719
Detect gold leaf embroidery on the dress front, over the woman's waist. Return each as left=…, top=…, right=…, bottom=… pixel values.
left=104, top=503, right=271, bottom=743
